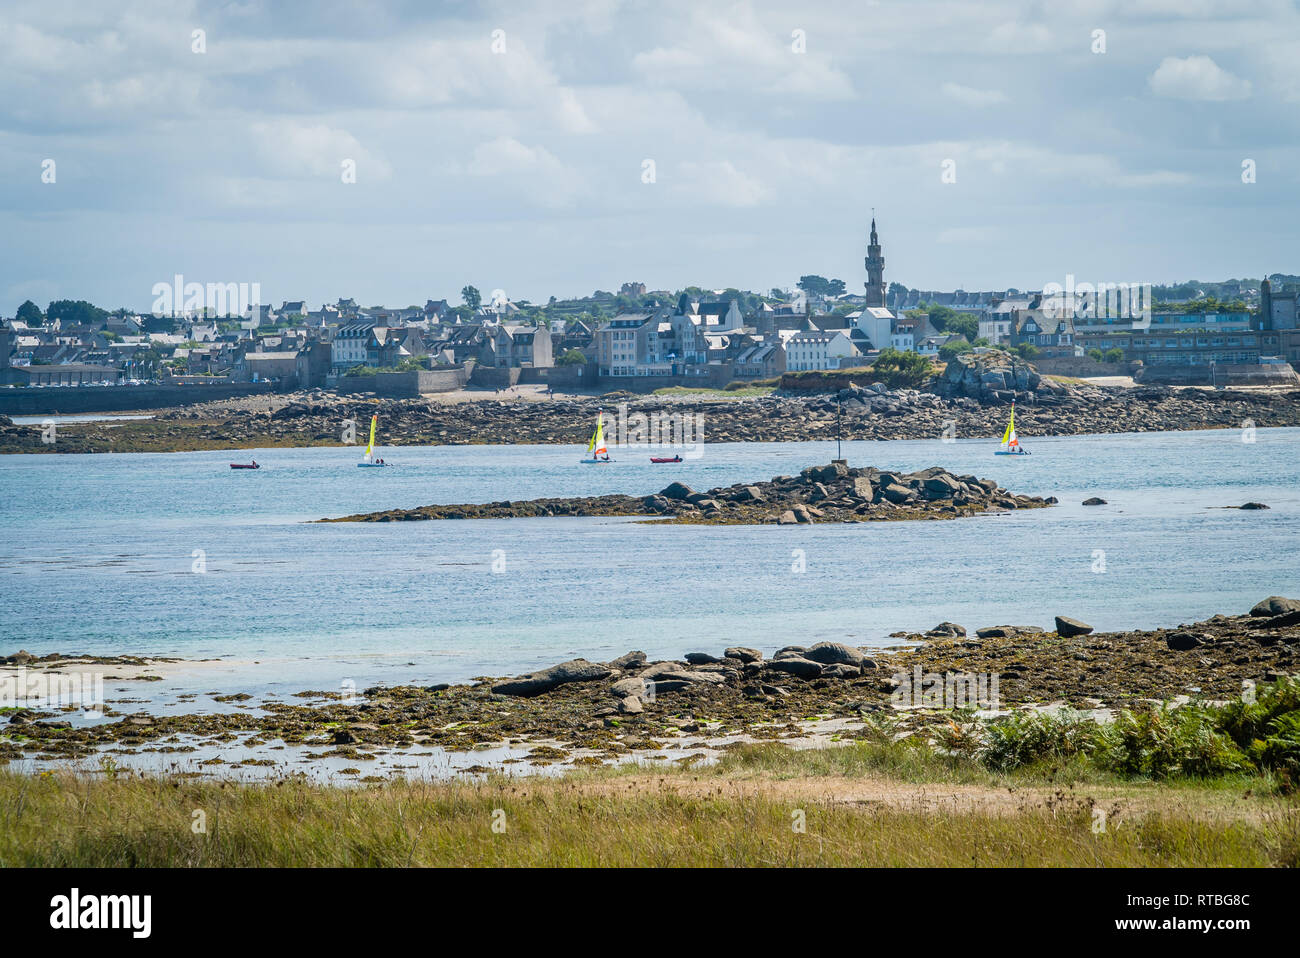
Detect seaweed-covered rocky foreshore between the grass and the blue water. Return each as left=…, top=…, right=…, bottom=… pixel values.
left=0, top=595, right=1300, bottom=771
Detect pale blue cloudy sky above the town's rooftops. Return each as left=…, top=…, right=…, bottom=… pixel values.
left=0, top=0, right=1300, bottom=316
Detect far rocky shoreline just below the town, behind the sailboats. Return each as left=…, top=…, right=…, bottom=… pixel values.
left=0, top=380, right=1300, bottom=452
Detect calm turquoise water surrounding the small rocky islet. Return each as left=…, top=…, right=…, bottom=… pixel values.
left=0, top=429, right=1300, bottom=693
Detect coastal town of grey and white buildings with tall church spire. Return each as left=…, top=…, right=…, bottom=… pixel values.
left=0, top=218, right=1300, bottom=412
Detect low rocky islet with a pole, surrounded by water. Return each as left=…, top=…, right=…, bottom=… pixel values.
left=319, top=463, right=1056, bottom=525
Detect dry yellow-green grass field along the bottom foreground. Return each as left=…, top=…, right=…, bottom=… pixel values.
left=0, top=744, right=1300, bottom=867
